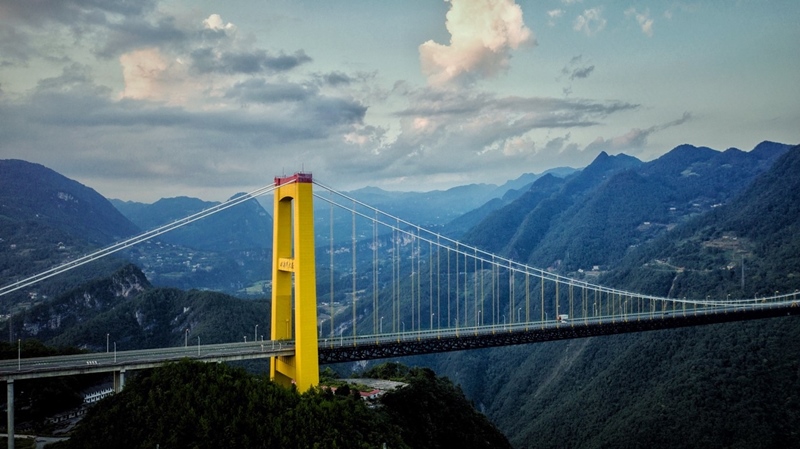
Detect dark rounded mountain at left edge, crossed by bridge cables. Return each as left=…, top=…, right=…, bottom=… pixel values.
left=0, top=160, right=138, bottom=313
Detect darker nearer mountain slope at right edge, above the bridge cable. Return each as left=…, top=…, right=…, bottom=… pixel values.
left=606, top=146, right=800, bottom=297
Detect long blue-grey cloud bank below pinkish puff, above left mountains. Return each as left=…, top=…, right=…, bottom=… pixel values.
left=0, top=65, right=366, bottom=196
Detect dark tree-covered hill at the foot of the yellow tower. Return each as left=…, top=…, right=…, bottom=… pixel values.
left=48, top=361, right=510, bottom=449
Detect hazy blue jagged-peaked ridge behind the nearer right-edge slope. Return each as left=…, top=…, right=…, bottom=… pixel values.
left=465, top=142, right=789, bottom=273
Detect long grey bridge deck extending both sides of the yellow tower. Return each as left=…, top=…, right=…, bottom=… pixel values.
left=0, top=304, right=800, bottom=381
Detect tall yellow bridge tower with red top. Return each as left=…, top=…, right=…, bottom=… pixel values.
left=270, top=173, right=319, bottom=391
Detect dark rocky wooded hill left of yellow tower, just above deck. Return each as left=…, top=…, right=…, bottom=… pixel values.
left=0, top=265, right=270, bottom=351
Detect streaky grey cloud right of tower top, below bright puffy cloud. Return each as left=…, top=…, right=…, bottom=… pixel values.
left=330, top=87, right=638, bottom=183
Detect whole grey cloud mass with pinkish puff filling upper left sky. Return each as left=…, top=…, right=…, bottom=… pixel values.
left=0, top=0, right=386, bottom=201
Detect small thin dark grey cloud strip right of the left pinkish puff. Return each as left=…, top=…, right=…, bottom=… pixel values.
left=191, top=47, right=311, bottom=75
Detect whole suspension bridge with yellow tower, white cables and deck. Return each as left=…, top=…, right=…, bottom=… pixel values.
left=0, top=173, right=800, bottom=447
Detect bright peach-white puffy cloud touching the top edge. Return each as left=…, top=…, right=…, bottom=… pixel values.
left=419, top=0, right=535, bottom=86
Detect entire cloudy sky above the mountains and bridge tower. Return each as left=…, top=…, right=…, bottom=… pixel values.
left=0, top=0, right=800, bottom=202
